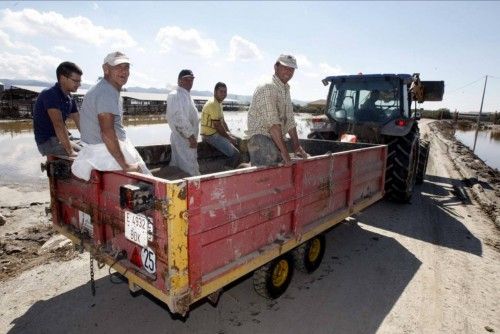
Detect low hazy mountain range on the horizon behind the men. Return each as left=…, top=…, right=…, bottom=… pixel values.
left=0, top=79, right=307, bottom=106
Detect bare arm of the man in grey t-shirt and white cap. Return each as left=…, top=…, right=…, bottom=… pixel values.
left=97, top=113, right=139, bottom=172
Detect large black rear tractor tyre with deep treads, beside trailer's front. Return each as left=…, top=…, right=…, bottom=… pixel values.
left=385, top=124, right=420, bottom=203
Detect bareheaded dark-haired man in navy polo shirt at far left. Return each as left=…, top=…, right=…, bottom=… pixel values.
left=33, top=61, right=82, bottom=157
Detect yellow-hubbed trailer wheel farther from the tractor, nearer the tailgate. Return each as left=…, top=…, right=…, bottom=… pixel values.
left=253, top=253, right=293, bottom=299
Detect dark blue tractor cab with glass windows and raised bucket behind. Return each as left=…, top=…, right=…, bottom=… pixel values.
left=309, top=74, right=444, bottom=143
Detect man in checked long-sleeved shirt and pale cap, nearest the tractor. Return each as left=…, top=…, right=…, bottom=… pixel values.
left=247, top=54, right=308, bottom=166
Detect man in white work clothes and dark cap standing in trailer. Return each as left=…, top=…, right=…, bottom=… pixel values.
left=167, top=70, right=200, bottom=176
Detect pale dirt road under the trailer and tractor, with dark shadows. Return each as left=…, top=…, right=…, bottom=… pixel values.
left=0, top=122, right=500, bottom=333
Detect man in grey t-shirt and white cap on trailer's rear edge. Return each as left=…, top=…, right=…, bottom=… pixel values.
left=72, top=52, right=150, bottom=180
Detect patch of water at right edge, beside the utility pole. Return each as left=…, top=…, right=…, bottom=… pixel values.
left=455, top=130, right=500, bottom=169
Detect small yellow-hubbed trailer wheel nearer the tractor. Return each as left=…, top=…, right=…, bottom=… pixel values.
left=293, top=234, right=326, bottom=273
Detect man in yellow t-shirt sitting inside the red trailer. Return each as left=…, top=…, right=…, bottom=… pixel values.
left=201, top=82, right=240, bottom=168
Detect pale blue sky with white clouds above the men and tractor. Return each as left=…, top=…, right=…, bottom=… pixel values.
left=0, top=1, right=500, bottom=111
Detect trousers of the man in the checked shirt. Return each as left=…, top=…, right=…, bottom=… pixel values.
left=248, top=135, right=283, bottom=166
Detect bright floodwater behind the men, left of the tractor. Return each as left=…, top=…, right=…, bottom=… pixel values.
left=0, top=111, right=311, bottom=184
